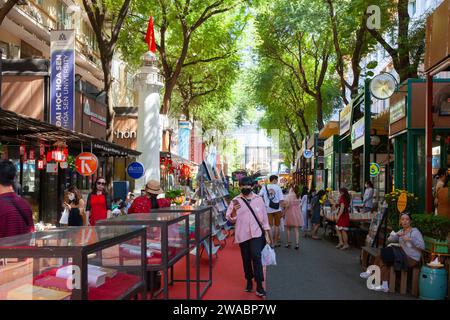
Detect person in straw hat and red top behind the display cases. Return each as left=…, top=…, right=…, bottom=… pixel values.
left=128, top=180, right=170, bottom=214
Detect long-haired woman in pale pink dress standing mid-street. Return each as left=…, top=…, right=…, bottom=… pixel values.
left=284, top=185, right=303, bottom=250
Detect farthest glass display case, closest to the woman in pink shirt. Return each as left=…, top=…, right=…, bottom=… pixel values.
left=155, top=206, right=213, bottom=299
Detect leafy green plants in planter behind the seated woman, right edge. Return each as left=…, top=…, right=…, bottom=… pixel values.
left=413, top=213, right=450, bottom=254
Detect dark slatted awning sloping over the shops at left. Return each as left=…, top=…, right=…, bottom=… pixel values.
left=0, top=109, right=141, bottom=157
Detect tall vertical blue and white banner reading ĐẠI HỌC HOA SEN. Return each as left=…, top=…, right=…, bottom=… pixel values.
left=50, top=30, right=75, bottom=130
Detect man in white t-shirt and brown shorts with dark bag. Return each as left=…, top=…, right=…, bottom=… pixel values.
left=259, top=175, right=284, bottom=247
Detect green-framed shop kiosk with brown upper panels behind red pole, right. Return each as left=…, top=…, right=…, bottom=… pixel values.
left=389, top=79, right=450, bottom=210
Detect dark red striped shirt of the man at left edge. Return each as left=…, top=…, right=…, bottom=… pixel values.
left=0, top=192, right=34, bottom=238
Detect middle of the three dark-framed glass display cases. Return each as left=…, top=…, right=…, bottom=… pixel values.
left=97, top=210, right=190, bottom=299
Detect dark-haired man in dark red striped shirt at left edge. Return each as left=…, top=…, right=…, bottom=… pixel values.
left=0, top=161, right=34, bottom=238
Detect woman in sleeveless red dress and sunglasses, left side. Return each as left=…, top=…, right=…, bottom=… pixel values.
left=86, top=177, right=111, bottom=226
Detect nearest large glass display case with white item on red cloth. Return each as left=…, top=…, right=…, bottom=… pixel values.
left=0, top=226, right=147, bottom=300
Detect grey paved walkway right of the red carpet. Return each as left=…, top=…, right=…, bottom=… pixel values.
left=267, top=230, right=414, bottom=300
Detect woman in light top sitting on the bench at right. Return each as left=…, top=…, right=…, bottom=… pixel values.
left=360, top=213, right=425, bottom=292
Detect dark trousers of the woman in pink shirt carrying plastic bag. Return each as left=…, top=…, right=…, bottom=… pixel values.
left=239, top=235, right=265, bottom=283
